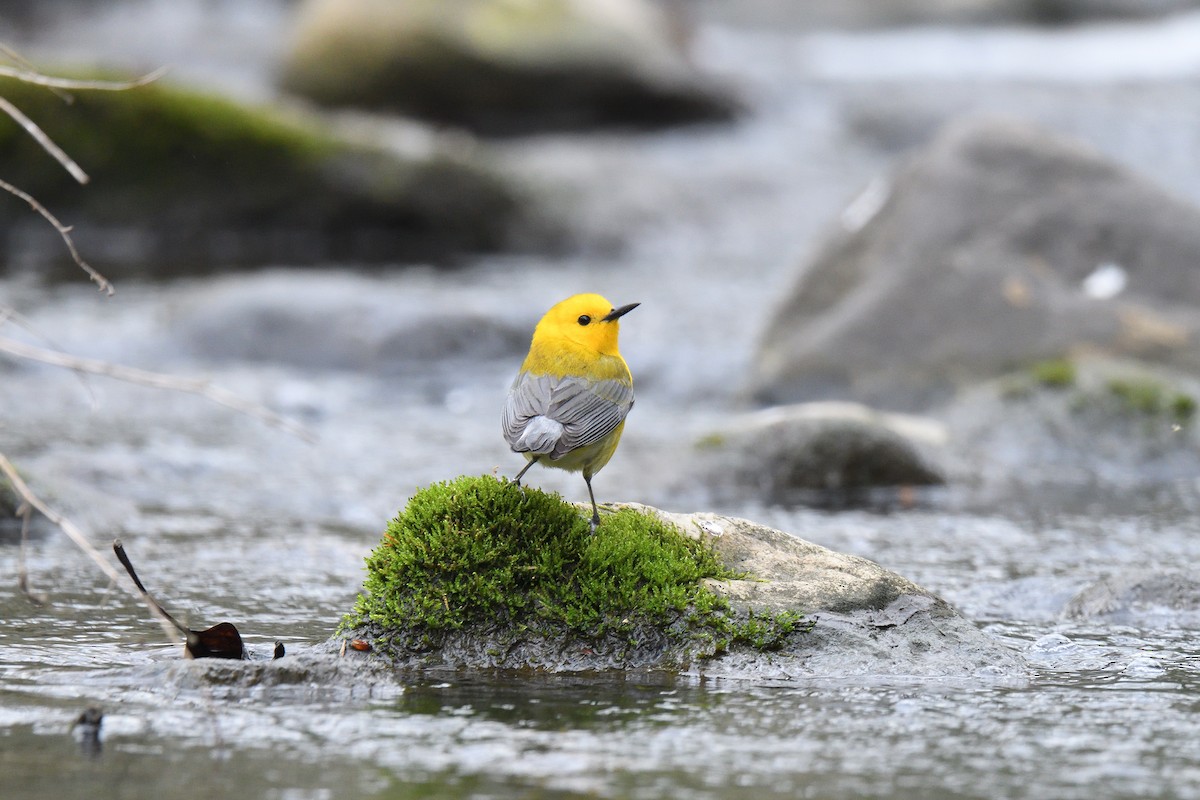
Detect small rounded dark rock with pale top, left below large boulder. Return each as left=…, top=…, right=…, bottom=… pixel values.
left=691, top=402, right=944, bottom=505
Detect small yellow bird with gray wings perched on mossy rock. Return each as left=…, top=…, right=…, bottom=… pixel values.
left=502, top=294, right=641, bottom=530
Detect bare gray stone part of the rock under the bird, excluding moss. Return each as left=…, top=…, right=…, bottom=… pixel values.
left=347, top=504, right=1024, bottom=681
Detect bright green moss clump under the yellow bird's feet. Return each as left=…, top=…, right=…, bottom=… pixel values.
left=343, top=476, right=802, bottom=655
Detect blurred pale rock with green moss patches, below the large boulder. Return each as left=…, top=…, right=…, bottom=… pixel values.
left=941, top=357, right=1200, bottom=513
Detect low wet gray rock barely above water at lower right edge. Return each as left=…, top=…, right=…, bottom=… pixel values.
left=1063, top=570, right=1200, bottom=622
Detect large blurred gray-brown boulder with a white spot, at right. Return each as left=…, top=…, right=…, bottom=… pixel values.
left=750, top=119, right=1200, bottom=409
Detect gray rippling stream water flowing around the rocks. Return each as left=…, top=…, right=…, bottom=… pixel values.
left=0, top=4, right=1200, bottom=800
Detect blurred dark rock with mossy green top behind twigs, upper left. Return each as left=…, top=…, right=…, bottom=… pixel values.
left=0, top=75, right=522, bottom=272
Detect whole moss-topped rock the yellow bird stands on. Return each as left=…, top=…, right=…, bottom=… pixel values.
left=338, top=477, right=1019, bottom=678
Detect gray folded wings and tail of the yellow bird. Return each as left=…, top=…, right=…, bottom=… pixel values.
left=502, top=372, right=634, bottom=458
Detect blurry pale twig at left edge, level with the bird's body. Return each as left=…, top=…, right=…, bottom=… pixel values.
left=0, top=336, right=317, bottom=443
